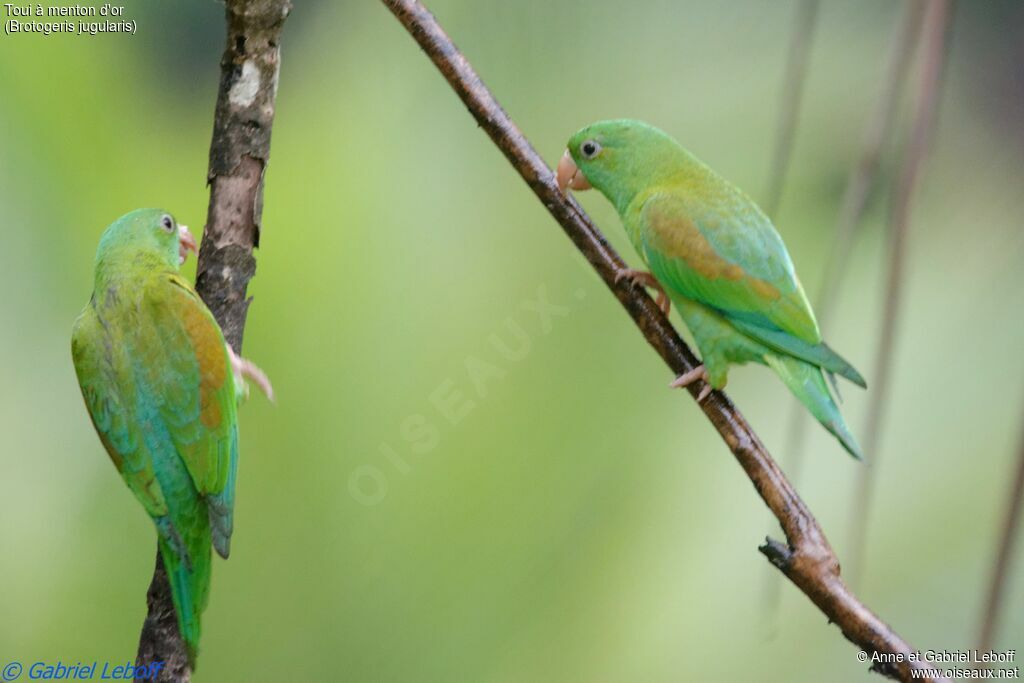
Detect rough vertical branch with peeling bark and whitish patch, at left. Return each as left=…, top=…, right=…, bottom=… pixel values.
left=136, top=0, right=292, bottom=683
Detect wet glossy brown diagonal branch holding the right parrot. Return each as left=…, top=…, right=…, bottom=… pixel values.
left=382, top=0, right=945, bottom=681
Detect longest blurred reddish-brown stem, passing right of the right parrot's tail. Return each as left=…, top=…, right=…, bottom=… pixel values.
left=847, top=0, right=952, bottom=586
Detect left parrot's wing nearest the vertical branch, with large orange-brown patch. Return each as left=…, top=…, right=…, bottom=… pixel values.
left=144, top=273, right=239, bottom=557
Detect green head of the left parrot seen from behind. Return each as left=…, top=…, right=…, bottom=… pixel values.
left=96, top=209, right=196, bottom=275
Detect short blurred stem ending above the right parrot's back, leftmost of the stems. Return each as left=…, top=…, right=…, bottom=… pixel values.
left=765, top=0, right=820, bottom=219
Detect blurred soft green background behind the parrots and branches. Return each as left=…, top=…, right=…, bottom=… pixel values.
left=0, top=0, right=1024, bottom=683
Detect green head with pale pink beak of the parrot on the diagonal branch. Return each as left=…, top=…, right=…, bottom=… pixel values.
left=557, top=119, right=691, bottom=213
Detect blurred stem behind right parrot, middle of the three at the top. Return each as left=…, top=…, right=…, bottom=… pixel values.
left=766, top=0, right=925, bottom=613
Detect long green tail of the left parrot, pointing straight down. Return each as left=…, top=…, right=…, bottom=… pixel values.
left=157, top=522, right=211, bottom=669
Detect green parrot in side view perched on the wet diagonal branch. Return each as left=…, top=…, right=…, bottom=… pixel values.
left=557, top=119, right=867, bottom=459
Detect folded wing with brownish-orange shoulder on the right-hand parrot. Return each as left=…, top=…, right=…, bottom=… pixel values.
left=639, top=193, right=865, bottom=386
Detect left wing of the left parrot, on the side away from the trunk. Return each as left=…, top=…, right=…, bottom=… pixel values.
left=71, top=303, right=168, bottom=518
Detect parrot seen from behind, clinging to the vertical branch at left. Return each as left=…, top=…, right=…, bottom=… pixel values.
left=72, top=209, right=272, bottom=664
